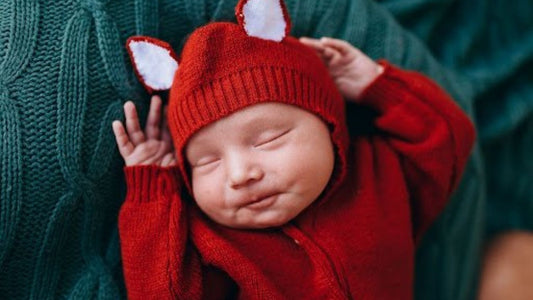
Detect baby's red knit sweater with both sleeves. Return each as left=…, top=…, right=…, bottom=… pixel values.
left=119, top=66, right=474, bottom=299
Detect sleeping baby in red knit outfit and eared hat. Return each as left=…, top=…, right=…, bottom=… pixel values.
left=113, top=0, right=474, bottom=299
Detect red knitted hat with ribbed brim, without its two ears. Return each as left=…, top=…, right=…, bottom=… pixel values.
left=168, top=22, right=348, bottom=187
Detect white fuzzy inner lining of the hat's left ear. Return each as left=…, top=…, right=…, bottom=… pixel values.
left=129, top=41, right=178, bottom=90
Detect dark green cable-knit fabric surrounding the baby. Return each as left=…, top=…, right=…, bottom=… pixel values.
left=0, top=0, right=533, bottom=299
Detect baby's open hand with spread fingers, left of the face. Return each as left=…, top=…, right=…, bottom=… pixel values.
left=113, top=96, right=176, bottom=167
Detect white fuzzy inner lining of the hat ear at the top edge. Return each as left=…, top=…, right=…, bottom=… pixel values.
left=243, top=0, right=287, bottom=42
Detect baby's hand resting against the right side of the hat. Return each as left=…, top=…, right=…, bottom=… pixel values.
left=300, top=37, right=383, bottom=101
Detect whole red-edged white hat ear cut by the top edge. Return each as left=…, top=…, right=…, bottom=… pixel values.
left=235, top=0, right=291, bottom=42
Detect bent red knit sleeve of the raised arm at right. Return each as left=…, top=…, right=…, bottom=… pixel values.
left=359, top=61, right=475, bottom=242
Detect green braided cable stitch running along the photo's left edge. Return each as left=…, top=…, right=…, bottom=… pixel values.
left=0, top=1, right=38, bottom=278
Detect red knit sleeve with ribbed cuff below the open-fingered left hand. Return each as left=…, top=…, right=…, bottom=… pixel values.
left=119, top=166, right=202, bottom=299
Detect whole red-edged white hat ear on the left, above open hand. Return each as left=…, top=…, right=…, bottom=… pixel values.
left=126, top=36, right=178, bottom=93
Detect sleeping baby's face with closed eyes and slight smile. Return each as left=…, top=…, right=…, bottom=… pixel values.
left=185, top=102, right=335, bottom=228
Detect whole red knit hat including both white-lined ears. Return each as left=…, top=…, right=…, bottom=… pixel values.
left=128, top=0, right=348, bottom=188
